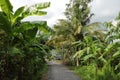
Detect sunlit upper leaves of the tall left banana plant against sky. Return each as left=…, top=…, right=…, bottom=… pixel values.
left=0, top=0, right=50, bottom=34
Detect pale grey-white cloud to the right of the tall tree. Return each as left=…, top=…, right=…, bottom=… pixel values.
left=91, top=0, right=120, bottom=22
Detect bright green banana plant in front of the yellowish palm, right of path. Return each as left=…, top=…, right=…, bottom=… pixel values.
left=73, top=36, right=104, bottom=64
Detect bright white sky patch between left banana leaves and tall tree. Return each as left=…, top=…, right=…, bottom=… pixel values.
left=11, top=0, right=69, bottom=26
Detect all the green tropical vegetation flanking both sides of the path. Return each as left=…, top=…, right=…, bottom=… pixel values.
left=0, top=0, right=120, bottom=80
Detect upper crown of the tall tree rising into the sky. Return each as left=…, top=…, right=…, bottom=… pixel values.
left=65, top=0, right=93, bottom=27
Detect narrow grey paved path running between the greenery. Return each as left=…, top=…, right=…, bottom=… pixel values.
left=48, top=62, right=80, bottom=80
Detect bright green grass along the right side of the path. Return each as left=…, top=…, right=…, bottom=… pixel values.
left=70, top=65, right=120, bottom=80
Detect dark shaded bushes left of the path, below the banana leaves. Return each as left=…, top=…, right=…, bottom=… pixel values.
left=0, top=46, right=46, bottom=80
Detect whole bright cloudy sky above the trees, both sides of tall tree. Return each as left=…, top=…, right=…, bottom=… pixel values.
left=10, top=0, right=120, bottom=27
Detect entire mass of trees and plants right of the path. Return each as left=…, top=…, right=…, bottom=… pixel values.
left=48, top=0, right=120, bottom=80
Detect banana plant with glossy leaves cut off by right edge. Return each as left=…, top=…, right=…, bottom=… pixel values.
left=96, top=14, right=120, bottom=73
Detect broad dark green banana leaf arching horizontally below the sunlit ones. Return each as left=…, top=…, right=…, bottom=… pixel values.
left=13, top=21, right=50, bottom=39
